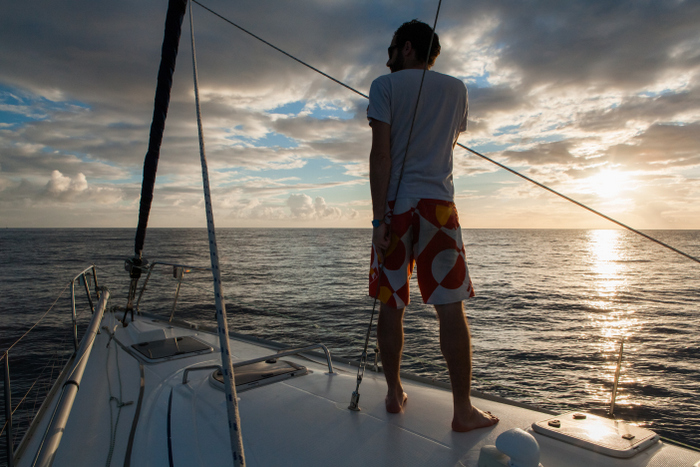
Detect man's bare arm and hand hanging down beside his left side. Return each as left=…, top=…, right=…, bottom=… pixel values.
left=369, top=119, right=391, bottom=250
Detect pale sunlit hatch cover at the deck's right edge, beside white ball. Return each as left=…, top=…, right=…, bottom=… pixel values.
left=532, top=412, right=659, bottom=458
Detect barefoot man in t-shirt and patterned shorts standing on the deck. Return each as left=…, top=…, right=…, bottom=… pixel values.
left=367, top=20, right=498, bottom=431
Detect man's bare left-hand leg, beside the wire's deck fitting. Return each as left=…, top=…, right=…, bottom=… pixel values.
left=377, top=303, right=408, bottom=413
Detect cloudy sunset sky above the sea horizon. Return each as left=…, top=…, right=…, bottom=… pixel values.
left=0, top=0, right=700, bottom=229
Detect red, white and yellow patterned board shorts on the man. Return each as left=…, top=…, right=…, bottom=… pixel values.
left=369, top=199, right=474, bottom=308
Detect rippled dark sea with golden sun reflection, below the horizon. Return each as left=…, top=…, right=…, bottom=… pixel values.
left=0, top=229, right=700, bottom=462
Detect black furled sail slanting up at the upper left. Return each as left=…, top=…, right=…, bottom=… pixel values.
left=134, top=0, right=187, bottom=263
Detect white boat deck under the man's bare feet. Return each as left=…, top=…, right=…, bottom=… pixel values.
left=16, top=313, right=700, bottom=467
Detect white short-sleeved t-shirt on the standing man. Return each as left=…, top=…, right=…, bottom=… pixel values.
left=367, top=69, right=468, bottom=201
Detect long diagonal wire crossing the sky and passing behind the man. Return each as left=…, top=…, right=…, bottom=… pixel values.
left=192, top=0, right=700, bottom=263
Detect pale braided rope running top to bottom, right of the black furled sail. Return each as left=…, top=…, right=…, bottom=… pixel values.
left=189, top=3, right=245, bottom=467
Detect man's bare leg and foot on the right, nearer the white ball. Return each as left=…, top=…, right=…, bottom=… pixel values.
left=438, top=302, right=498, bottom=431
